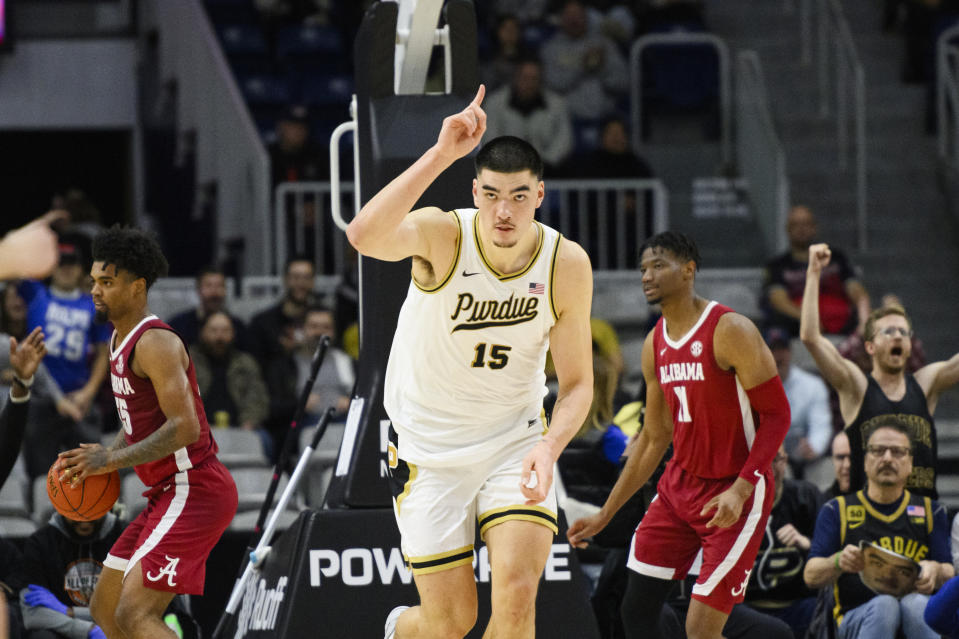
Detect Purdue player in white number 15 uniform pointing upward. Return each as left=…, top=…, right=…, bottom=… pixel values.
left=347, top=86, right=593, bottom=639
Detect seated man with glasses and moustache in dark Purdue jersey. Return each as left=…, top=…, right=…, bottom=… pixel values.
left=803, top=417, right=955, bottom=639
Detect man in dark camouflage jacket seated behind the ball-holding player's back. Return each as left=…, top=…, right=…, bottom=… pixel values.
left=190, top=311, right=273, bottom=457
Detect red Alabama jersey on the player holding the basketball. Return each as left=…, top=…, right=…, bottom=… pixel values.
left=110, top=315, right=217, bottom=486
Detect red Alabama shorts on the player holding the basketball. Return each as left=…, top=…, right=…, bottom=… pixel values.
left=103, top=458, right=237, bottom=595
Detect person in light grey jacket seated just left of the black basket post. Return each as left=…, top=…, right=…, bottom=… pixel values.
left=294, top=306, right=356, bottom=418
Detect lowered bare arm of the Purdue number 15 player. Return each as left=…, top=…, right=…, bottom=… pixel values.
left=520, top=240, right=593, bottom=504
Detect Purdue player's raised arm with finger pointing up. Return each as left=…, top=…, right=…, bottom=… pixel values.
left=346, top=85, right=486, bottom=262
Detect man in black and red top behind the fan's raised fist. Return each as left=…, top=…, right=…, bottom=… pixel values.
left=760, top=205, right=870, bottom=337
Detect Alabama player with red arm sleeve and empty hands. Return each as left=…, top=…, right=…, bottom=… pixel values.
left=567, top=231, right=789, bottom=639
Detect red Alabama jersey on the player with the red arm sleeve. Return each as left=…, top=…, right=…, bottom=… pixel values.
left=653, top=302, right=758, bottom=479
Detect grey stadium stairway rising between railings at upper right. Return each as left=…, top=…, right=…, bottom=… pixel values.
left=708, top=0, right=959, bottom=422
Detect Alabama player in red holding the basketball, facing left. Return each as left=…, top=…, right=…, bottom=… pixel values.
left=58, top=226, right=237, bottom=639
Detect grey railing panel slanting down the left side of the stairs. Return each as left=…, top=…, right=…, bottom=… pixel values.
left=736, top=51, right=789, bottom=255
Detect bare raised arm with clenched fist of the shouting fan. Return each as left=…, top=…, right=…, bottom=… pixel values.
left=799, top=244, right=867, bottom=404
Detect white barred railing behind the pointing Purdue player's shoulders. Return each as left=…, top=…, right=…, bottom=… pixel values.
left=271, top=178, right=669, bottom=276
